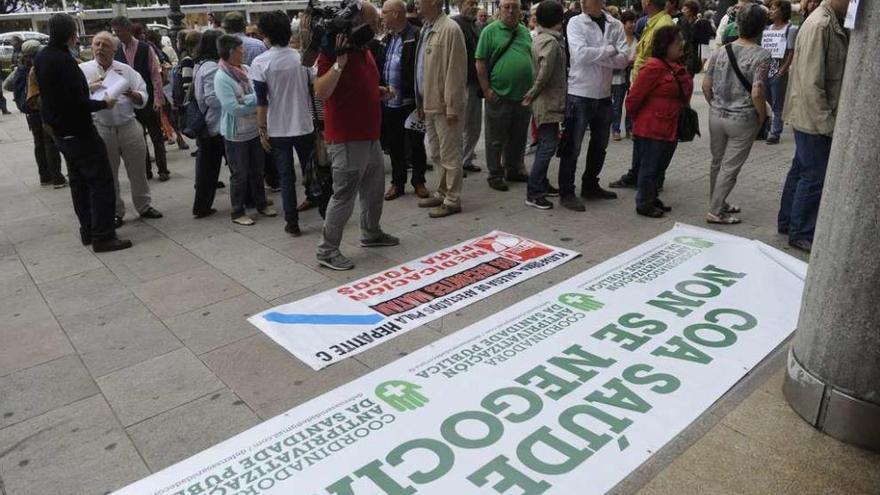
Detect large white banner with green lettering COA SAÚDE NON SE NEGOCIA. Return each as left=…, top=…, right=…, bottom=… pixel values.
left=117, top=226, right=806, bottom=495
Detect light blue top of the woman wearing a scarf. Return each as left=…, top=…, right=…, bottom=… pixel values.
left=214, top=68, right=259, bottom=142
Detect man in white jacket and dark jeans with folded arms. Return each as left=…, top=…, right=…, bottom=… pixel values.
left=559, top=0, right=631, bottom=211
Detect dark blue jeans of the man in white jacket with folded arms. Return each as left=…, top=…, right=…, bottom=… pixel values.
left=559, top=95, right=611, bottom=196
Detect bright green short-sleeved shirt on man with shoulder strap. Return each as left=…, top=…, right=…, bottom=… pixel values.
left=475, top=21, right=535, bottom=100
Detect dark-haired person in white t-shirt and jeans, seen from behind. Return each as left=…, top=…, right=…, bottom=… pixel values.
left=250, top=11, right=321, bottom=236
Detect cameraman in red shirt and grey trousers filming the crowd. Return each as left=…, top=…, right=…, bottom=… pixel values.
left=315, top=2, right=400, bottom=270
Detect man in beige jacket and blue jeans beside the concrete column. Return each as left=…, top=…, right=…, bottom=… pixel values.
left=777, top=0, right=849, bottom=252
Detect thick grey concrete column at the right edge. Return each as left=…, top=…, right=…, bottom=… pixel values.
left=783, top=0, right=880, bottom=451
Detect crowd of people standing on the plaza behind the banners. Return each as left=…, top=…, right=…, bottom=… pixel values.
left=4, top=0, right=849, bottom=264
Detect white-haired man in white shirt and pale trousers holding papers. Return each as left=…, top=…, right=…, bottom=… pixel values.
left=79, top=31, right=162, bottom=228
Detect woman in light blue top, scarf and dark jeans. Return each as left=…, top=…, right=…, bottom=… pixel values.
left=214, top=35, right=278, bottom=225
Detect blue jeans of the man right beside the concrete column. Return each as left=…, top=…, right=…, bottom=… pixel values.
left=777, top=130, right=831, bottom=241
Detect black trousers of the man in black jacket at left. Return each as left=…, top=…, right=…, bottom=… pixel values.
left=55, top=126, right=116, bottom=241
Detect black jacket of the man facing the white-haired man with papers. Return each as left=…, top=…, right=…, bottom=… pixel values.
left=34, top=45, right=107, bottom=136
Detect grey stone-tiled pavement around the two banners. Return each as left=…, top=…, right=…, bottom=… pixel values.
left=0, top=89, right=880, bottom=495
